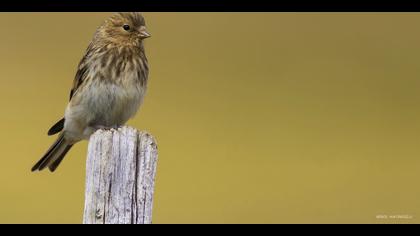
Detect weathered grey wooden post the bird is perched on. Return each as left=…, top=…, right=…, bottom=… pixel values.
left=83, top=127, right=158, bottom=224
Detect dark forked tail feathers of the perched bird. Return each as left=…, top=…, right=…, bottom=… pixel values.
left=32, top=133, right=73, bottom=172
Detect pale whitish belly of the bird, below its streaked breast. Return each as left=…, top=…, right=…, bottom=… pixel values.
left=64, top=80, right=146, bottom=141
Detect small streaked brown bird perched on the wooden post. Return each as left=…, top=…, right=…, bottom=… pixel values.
left=32, top=13, right=150, bottom=172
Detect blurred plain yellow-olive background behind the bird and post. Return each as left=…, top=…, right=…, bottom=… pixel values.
left=0, top=13, right=420, bottom=223
